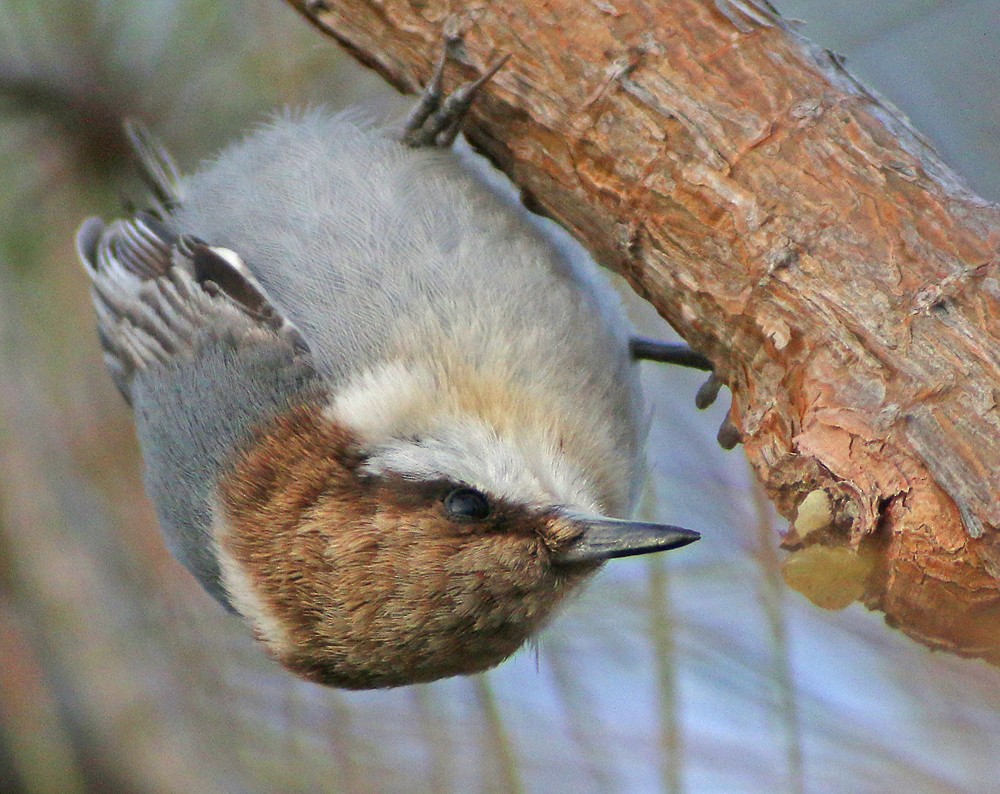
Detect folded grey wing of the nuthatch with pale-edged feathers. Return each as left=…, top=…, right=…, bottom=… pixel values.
left=77, top=213, right=328, bottom=607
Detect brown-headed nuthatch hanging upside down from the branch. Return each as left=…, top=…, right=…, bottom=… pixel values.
left=77, top=44, right=707, bottom=688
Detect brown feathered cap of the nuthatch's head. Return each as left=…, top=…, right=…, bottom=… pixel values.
left=216, top=407, right=596, bottom=689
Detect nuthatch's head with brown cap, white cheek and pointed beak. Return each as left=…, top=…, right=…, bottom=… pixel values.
left=215, top=360, right=698, bottom=689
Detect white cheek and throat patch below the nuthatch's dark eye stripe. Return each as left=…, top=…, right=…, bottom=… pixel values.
left=324, top=362, right=600, bottom=512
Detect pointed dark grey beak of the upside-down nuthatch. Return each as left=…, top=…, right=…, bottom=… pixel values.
left=552, top=510, right=701, bottom=565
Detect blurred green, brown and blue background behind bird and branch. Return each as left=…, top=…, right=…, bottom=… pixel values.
left=0, top=0, right=1000, bottom=794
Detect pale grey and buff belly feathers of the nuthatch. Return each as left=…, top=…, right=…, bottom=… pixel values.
left=173, top=110, right=644, bottom=515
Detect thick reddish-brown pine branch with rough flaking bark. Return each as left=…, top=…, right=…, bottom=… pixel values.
left=290, top=0, right=1000, bottom=663
